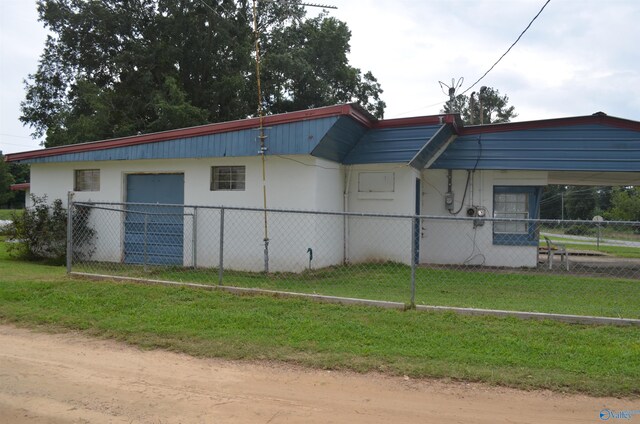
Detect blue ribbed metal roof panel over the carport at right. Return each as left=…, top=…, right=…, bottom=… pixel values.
left=431, top=124, right=640, bottom=171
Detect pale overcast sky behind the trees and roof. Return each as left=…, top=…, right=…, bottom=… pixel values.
left=0, top=0, right=640, bottom=153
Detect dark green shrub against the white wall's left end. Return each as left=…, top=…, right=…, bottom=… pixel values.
left=8, top=194, right=95, bottom=264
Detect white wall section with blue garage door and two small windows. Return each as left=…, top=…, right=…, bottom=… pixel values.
left=31, top=156, right=344, bottom=271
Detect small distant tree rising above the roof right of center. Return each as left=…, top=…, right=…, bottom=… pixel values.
left=441, top=86, right=518, bottom=125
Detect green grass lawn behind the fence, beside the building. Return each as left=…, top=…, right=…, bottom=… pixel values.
left=74, top=263, right=640, bottom=318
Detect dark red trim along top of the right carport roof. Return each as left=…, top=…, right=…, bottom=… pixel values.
left=459, top=115, right=640, bottom=135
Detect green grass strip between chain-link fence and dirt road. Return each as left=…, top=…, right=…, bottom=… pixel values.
left=0, top=238, right=640, bottom=396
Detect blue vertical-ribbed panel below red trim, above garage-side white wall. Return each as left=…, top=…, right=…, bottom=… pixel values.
left=22, top=116, right=339, bottom=163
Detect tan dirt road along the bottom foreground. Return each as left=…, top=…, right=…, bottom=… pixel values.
left=0, top=326, right=640, bottom=424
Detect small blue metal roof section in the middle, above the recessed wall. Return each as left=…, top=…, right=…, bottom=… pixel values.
left=344, top=124, right=444, bottom=165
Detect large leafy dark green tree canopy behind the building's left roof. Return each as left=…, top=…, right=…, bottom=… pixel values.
left=20, top=0, right=385, bottom=147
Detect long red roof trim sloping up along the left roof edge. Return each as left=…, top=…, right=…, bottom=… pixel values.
left=5, top=104, right=375, bottom=162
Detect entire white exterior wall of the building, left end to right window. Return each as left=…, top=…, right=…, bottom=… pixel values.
left=31, top=156, right=547, bottom=272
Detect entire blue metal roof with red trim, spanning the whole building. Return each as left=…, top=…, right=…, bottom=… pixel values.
left=12, top=105, right=640, bottom=172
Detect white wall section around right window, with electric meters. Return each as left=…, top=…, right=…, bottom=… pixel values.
left=420, top=170, right=547, bottom=267
